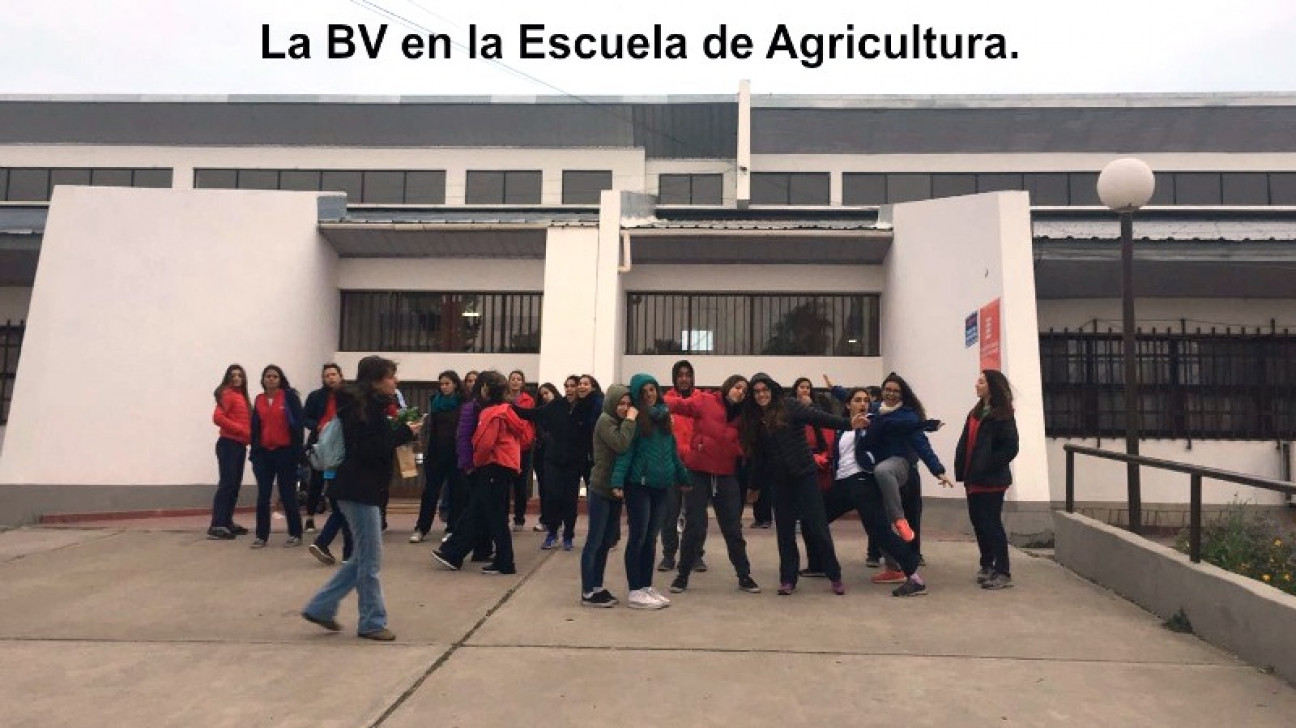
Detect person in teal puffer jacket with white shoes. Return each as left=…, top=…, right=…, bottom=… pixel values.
left=612, top=374, right=692, bottom=609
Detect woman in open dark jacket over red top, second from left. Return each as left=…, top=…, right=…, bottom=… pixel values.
left=248, top=364, right=305, bottom=548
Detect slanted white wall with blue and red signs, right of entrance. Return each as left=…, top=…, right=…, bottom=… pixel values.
left=881, top=192, right=1050, bottom=501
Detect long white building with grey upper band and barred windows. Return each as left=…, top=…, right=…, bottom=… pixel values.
left=0, top=89, right=1296, bottom=535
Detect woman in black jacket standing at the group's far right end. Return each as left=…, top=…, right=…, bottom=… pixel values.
left=954, top=369, right=1017, bottom=589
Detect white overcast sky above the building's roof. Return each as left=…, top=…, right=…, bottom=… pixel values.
left=0, top=0, right=1296, bottom=96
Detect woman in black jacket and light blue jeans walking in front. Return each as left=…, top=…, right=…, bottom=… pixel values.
left=302, top=356, right=422, bottom=641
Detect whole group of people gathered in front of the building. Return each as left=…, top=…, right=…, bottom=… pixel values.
left=207, top=356, right=1017, bottom=640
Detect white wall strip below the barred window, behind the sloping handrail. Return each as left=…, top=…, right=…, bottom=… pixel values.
left=1048, top=438, right=1287, bottom=505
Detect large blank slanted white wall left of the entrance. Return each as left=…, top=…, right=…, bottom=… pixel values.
left=0, top=183, right=338, bottom=486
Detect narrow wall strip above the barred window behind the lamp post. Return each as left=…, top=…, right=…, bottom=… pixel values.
left=1038, top=296, right=1296, bottom=333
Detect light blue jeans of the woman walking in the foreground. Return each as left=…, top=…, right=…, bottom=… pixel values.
left=302, top=500, right=388, bottom=635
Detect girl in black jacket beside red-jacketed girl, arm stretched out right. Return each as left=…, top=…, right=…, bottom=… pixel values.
left=740, top=373, right=866, bottom=596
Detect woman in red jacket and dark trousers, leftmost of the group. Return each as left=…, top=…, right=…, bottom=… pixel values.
left=207, top=364, right=251, bottom=540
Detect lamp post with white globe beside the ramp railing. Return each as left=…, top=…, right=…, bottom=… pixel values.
left=1098, top=158, right=1156, bottom=534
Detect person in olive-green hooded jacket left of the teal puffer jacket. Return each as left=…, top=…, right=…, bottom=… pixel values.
left=581, top=385, right=639, bottom=606
